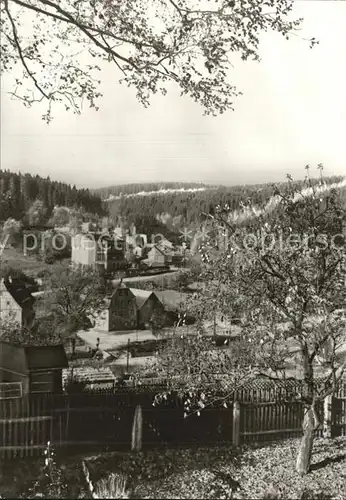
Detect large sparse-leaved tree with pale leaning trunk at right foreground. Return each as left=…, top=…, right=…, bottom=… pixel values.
left=155, top=165, right=346, bottom=474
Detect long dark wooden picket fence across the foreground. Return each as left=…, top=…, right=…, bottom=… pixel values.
left=0, top=383, right=346, bottom=458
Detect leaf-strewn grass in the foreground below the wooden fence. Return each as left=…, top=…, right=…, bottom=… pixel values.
left=0, top=437, right=346, bottom=500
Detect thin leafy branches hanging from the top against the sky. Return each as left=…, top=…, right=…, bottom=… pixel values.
left=0, top=0, right=317, bottom=122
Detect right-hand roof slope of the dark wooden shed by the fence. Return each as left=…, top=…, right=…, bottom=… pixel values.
left=24, top=344, right=68, bottom=370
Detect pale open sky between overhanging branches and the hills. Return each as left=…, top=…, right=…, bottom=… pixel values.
left=1, top=0, right=346, bottom=188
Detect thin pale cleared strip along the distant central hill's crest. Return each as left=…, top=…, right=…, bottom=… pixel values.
left=93, top=182, right=213, bottom=200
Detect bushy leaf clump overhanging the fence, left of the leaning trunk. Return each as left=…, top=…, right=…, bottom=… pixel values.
left=154, top=332, right=254, bottom=416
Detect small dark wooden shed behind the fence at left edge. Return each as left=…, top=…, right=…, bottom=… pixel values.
left=0, top=341, right=68, bottom=394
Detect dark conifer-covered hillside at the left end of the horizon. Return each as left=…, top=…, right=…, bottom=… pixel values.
left=0, top=170, right=104, bottom=221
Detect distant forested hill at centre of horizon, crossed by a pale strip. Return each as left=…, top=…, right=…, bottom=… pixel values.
left=104, top=177, right=346, bottom=227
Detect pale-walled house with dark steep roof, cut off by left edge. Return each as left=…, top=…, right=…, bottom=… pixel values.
left=0, top=277, right=35, bottom=328
